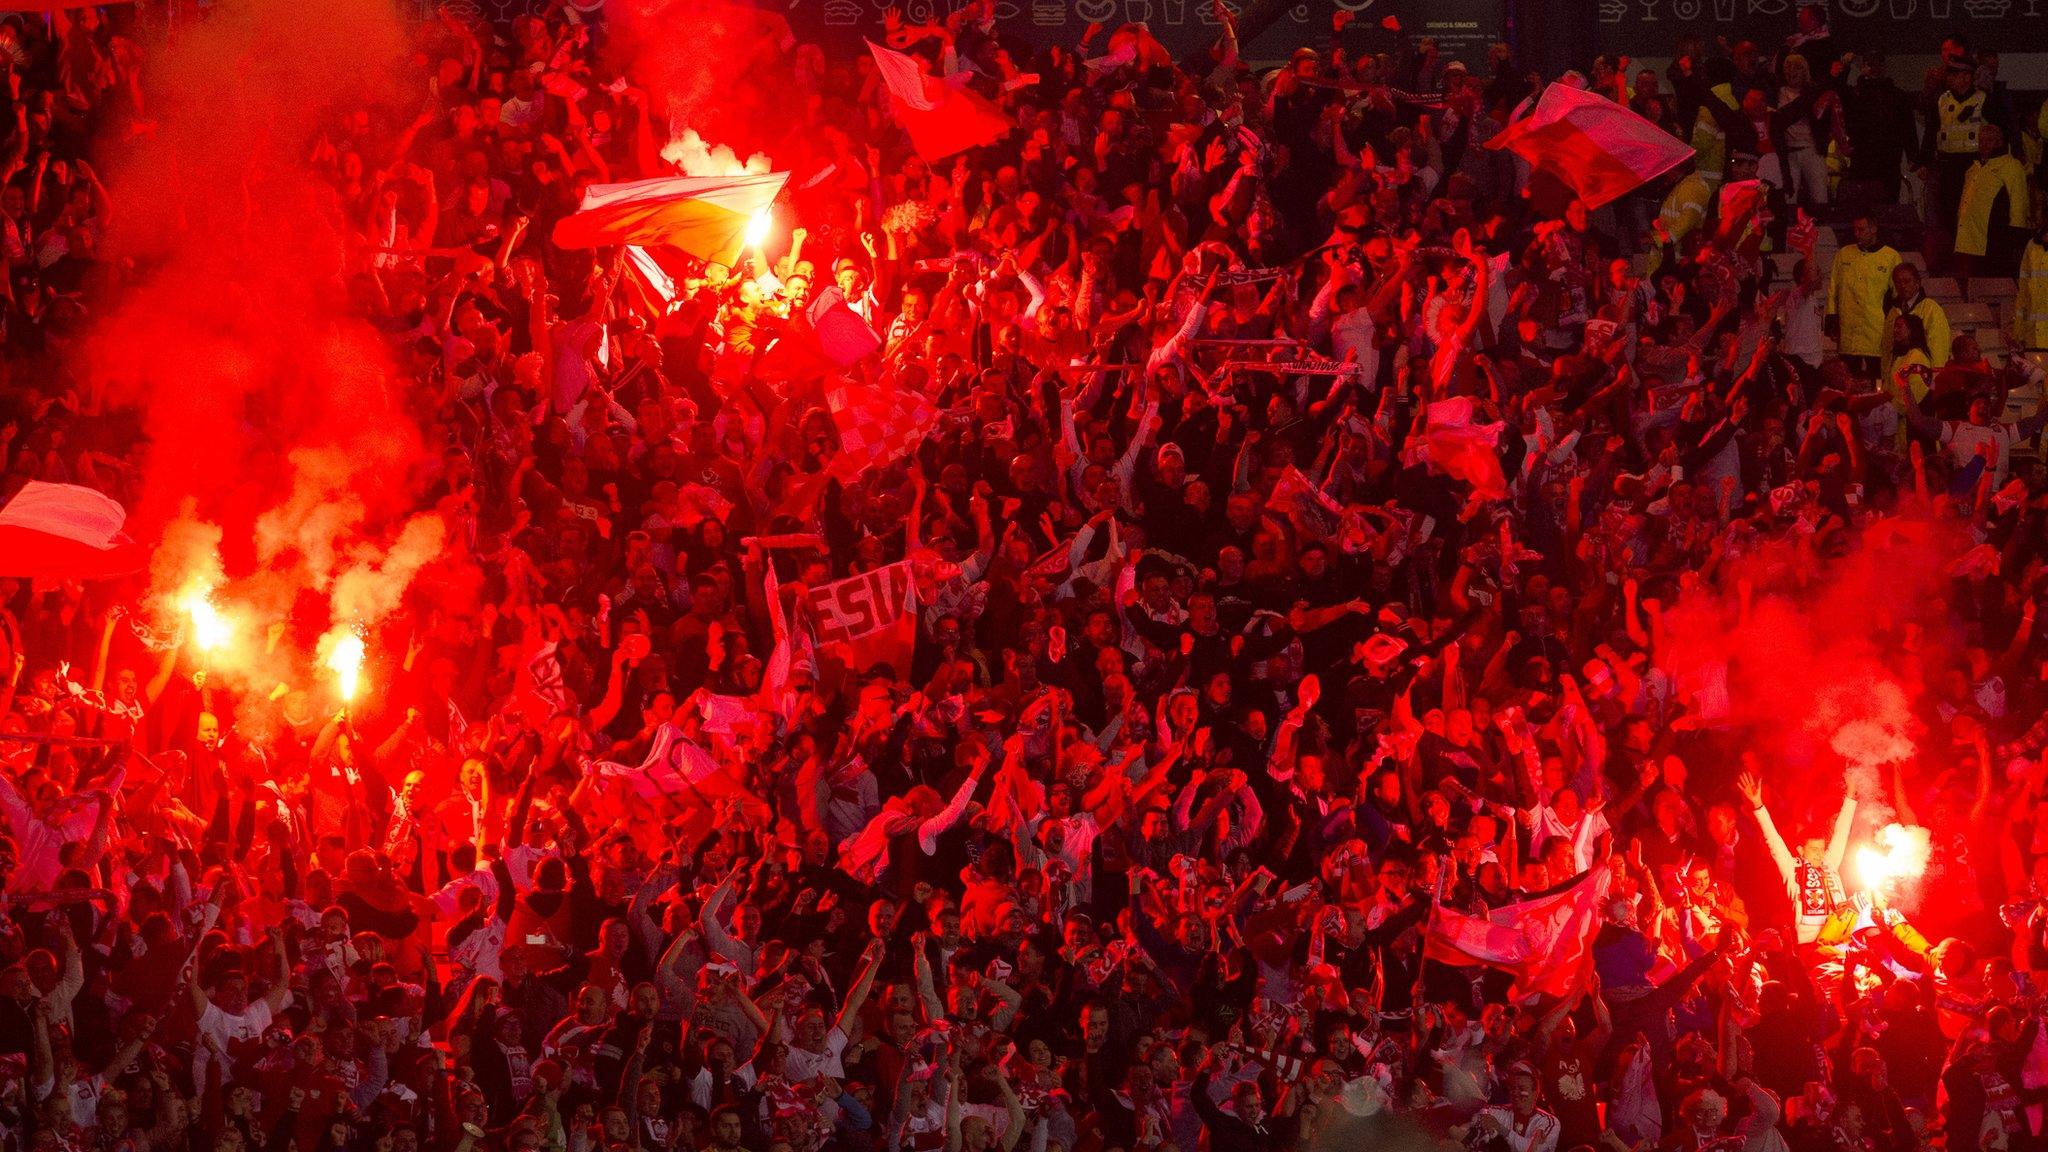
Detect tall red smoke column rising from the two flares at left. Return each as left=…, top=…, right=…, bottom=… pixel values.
left=84, top=0, right=460, bottom=705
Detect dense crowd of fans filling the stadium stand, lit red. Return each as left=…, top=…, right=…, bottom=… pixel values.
left=0, top=6, right=2048, bottom=1152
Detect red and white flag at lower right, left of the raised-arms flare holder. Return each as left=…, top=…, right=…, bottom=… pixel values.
left=1423, top=863, right=1612, bottom=1000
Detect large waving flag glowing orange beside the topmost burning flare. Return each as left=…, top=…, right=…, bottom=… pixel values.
left=555, top=172, right=788, bottom=264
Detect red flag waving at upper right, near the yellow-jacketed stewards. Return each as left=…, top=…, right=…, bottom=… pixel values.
left=1487, top=84, right=1692, bottom=211
